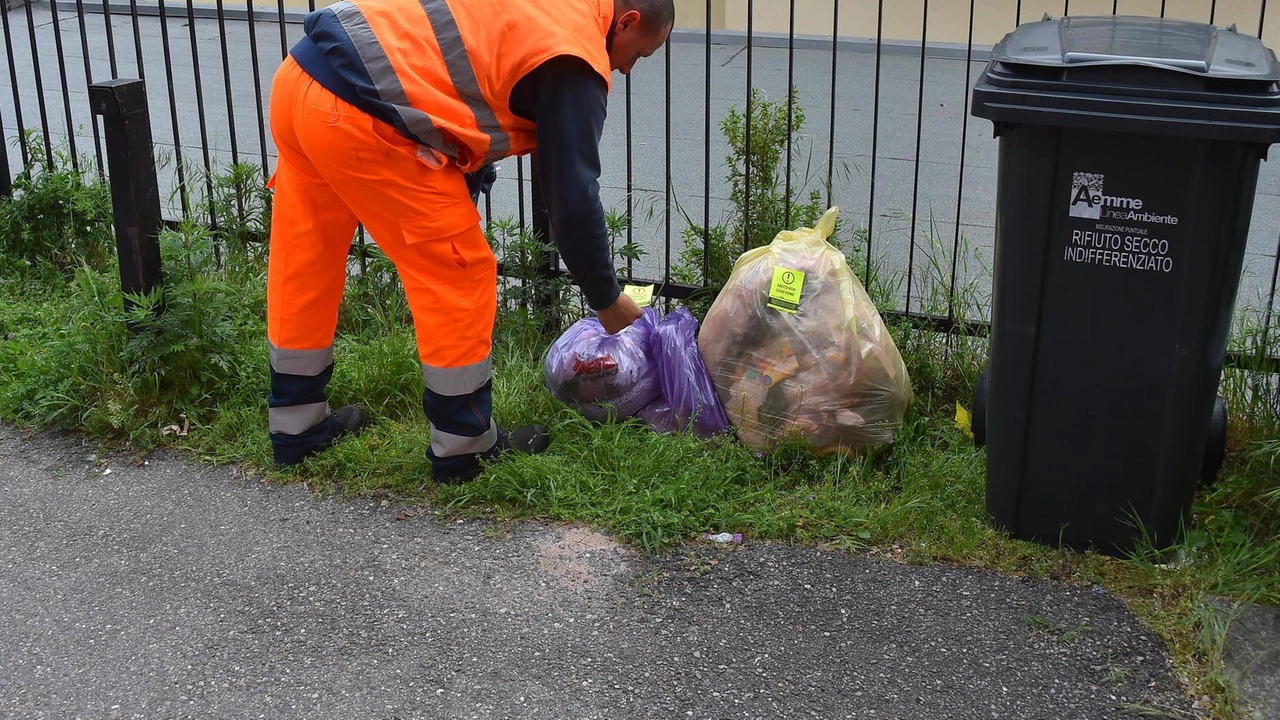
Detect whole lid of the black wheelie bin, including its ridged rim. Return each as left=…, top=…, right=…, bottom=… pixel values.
left=973, top=15, right=1280, bottom=145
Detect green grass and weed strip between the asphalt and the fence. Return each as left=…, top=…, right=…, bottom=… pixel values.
left=0, top=262, right=1280, bottom=717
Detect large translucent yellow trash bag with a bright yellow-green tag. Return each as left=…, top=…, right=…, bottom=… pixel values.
left=699, top=208, right=913, bottom=455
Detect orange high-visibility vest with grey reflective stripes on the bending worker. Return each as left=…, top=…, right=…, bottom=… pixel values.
left=293, top=0, right=613, bottom=172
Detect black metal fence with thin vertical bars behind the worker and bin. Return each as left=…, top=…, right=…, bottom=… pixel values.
left=0, top=0, right=1280, bottom=353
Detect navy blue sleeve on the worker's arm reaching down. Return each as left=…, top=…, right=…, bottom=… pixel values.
left=511, top=56, right=621, bottom=310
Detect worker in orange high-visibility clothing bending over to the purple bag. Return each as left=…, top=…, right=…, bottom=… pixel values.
left=266, top=0, right=675, bottom=483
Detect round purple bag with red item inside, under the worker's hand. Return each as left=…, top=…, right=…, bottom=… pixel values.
left=543, top=307, right=659, bottom=423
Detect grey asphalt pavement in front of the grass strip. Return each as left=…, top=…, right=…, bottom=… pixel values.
left=0, top=428, right=1228, bottom=720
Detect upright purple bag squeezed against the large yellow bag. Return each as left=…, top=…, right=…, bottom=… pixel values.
left=640, top=307, right=730, bottom=439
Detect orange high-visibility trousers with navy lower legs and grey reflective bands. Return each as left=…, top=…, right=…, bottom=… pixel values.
left=266, top=58, right=498, bottom=475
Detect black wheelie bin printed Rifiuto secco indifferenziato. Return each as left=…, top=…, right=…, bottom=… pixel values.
left=972, top=17, right=1280, bottom=555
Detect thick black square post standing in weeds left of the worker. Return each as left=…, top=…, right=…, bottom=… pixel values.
left=88, top=79, right=163, bottom=310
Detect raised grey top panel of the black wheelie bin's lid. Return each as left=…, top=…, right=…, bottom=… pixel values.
left=991, top=15, right=1280, bottom=83
